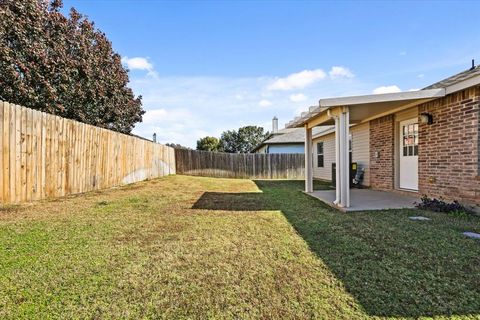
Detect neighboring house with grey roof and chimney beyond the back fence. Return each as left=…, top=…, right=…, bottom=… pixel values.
left=251, top=117, right=328, bottom=153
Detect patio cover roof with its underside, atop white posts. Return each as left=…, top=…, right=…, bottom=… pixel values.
left=286, top=88, right=445, bottom=128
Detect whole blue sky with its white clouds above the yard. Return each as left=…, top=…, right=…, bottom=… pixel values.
left=64, top=0, right=480, bottom=147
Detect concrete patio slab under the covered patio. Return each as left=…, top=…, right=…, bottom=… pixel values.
left=307, top=189, right=420, bottom=212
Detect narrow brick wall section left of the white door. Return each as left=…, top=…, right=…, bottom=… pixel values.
left=370, top=115, right=395, bottom=190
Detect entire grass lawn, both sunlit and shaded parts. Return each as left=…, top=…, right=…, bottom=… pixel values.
left=0, top=176, right=480, bottom=319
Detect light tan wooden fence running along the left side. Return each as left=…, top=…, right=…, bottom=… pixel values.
left=0, top=101, right=175, bottom=203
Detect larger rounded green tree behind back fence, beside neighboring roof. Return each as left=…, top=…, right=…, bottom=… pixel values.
left=220, top=126, right=268, bottom=153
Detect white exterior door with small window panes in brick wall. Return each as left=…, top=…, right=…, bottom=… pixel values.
left=399, top=118, right=418, bottom=190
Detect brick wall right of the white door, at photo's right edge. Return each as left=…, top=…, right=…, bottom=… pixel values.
left=418, top=87, right=480, bottom=205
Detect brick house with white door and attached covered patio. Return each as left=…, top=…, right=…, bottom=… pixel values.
left=286, top=67, right=480, bottom=207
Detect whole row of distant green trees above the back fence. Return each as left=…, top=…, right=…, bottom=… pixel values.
left=197, top=126, right=268, bottom=153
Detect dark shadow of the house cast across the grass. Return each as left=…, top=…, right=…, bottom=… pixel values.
left=194, top=180, right=480, bottom=317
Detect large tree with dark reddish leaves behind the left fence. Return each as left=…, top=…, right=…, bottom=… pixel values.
left=0, top=0, right=144, bottom=133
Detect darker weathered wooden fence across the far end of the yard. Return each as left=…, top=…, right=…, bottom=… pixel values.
left=175, top=149, right=305, bottom=179
